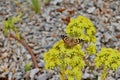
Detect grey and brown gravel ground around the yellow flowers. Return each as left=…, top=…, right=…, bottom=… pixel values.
left=0, top=0, right=120, bottom=80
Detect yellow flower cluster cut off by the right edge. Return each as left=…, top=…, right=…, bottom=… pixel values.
left=95, top=48, right=120, bottom=70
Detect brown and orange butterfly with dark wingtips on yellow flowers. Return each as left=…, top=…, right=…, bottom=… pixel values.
left=61, top=35, right=82, bottom=47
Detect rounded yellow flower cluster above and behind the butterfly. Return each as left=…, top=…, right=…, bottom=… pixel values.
left=66, top=16, right=96, bottom=42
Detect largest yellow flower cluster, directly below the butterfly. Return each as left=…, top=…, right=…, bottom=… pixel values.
left=44, top=40, right=85, bottom=80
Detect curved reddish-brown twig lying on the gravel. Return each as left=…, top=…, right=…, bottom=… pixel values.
left=9, top=34, right=38, bottom=68
